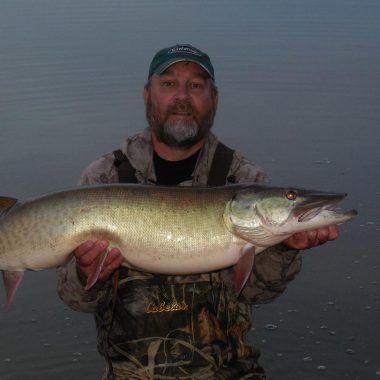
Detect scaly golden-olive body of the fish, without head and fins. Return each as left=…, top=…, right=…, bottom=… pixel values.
left=0, top=186, right=243, bottom=273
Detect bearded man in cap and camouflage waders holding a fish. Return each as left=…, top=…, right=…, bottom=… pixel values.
left=58, top=45, right=338, bottom=379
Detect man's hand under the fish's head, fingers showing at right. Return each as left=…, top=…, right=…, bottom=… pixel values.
left=282, top=226, right=339, bottom=249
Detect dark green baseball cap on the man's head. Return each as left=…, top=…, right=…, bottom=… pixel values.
left=148, top=44, right=215, bottom=80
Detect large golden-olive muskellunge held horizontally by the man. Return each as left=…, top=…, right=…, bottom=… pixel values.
left=0, top=184, right=356, bottom=304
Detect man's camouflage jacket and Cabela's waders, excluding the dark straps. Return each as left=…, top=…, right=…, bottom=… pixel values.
left=58, top=129, right=301, bottom=379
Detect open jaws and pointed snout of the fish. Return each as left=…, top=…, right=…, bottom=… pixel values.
left=293, top=192, right=357, bottom=223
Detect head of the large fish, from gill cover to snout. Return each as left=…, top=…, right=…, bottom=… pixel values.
left=229, top=185, right=357, bottom=247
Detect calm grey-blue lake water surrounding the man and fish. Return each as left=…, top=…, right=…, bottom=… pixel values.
left=0, top=0, right=380, bottom=380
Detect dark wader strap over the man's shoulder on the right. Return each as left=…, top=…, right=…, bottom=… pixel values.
left=207, top=142, right=235, bottom=186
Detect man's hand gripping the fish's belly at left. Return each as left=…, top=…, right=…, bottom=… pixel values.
left=73, top=240, right=124, bottom=281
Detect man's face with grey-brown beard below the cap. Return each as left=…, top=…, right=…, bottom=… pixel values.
left=144, top=62, right=218, bottom=149
